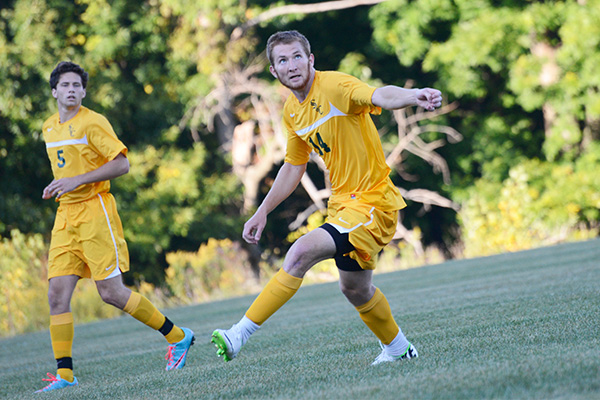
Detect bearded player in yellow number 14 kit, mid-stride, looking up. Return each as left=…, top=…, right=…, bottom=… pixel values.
left=212, top=31, right=442, bottom=365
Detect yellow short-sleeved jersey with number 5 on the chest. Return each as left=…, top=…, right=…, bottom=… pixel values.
left=42, top=106, right=127, bottom=204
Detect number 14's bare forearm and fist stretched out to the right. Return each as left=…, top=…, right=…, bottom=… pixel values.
left=371, top=85, right=442, bottom=111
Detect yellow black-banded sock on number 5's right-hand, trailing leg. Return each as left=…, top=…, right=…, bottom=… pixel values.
left=123, top=292, right=185, bottom=343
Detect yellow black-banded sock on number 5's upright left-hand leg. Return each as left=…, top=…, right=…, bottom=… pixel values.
left=50, top=312, right=74, bottom=382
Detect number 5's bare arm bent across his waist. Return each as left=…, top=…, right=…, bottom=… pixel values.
left=42, top=153, right=129, bottom=199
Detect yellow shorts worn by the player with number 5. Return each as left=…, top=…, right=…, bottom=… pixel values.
left=48, top=193, right=129, bottom=281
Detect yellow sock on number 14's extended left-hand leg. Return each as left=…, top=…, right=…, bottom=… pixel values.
left=246, top=268, right=302, bottom=325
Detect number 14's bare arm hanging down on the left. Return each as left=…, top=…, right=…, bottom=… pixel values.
left=242, top=162, right=306, bottom=244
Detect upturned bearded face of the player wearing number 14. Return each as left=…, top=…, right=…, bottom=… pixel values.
left=269, top=42, right=314, bottom=91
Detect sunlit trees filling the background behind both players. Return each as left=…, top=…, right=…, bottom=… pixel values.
left=0, top=0, right=600, bottom=300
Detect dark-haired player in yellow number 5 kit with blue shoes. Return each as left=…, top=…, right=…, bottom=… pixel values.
left=38, top=62, right=194, bottom=392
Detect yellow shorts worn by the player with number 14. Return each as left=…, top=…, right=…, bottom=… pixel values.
left=326, top=201, right=398, bottom=270
